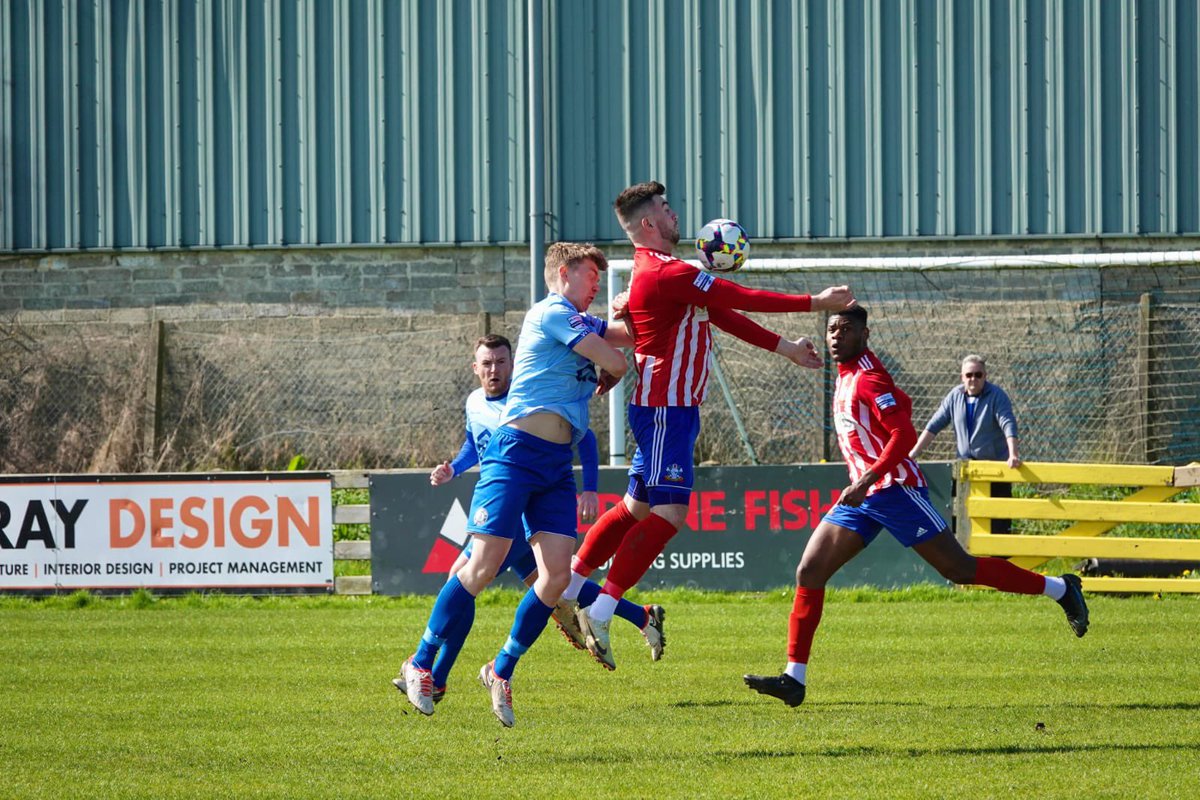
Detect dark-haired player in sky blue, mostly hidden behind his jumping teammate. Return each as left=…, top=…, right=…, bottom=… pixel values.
left=391, top=333, right=666, bottom=703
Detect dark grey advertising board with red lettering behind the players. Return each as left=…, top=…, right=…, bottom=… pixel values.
left=371, top=464, right=952, bottom=595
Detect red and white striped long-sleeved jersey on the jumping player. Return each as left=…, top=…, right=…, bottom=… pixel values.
left=629, top=247, right=812, bottom=407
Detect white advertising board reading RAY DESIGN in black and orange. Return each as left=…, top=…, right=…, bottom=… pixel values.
left=0, top=473, right=334, bottom=591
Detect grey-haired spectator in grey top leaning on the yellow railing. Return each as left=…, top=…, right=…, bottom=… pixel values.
left=908, top=355, right=1021, bottom=534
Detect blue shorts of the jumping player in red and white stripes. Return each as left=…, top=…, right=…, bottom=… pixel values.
left=626, top=405, right=700, bottom=506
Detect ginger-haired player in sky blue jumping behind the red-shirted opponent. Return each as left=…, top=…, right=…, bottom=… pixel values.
left=404, top=243, right=631, bottom=727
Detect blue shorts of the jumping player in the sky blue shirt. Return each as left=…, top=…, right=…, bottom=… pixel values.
left=467, top=426, right=576, bottom=540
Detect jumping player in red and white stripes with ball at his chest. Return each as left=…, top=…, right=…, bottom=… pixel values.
left=563, top=181, right=854, bottom=669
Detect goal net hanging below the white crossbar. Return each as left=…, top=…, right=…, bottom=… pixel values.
left=702, top=265, right=1200, bottom=464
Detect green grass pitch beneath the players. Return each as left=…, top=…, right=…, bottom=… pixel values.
left=0, top=589, right=1200, bottom=800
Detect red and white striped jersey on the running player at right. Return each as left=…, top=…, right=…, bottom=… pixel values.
left=833, top=350, right=928, bottom=495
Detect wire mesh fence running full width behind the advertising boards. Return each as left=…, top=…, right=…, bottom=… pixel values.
left=0, top=265, right=1200, bottom=473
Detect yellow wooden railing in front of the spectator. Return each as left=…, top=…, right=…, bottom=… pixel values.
left=959, top=461, right=1200, bottom=593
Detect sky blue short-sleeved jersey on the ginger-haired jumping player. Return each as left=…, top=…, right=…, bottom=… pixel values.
left=500, top=293, right=608, bottom=444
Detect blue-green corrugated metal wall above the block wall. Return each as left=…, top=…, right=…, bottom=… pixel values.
left=0, top=0, right=1200, bottom=249
